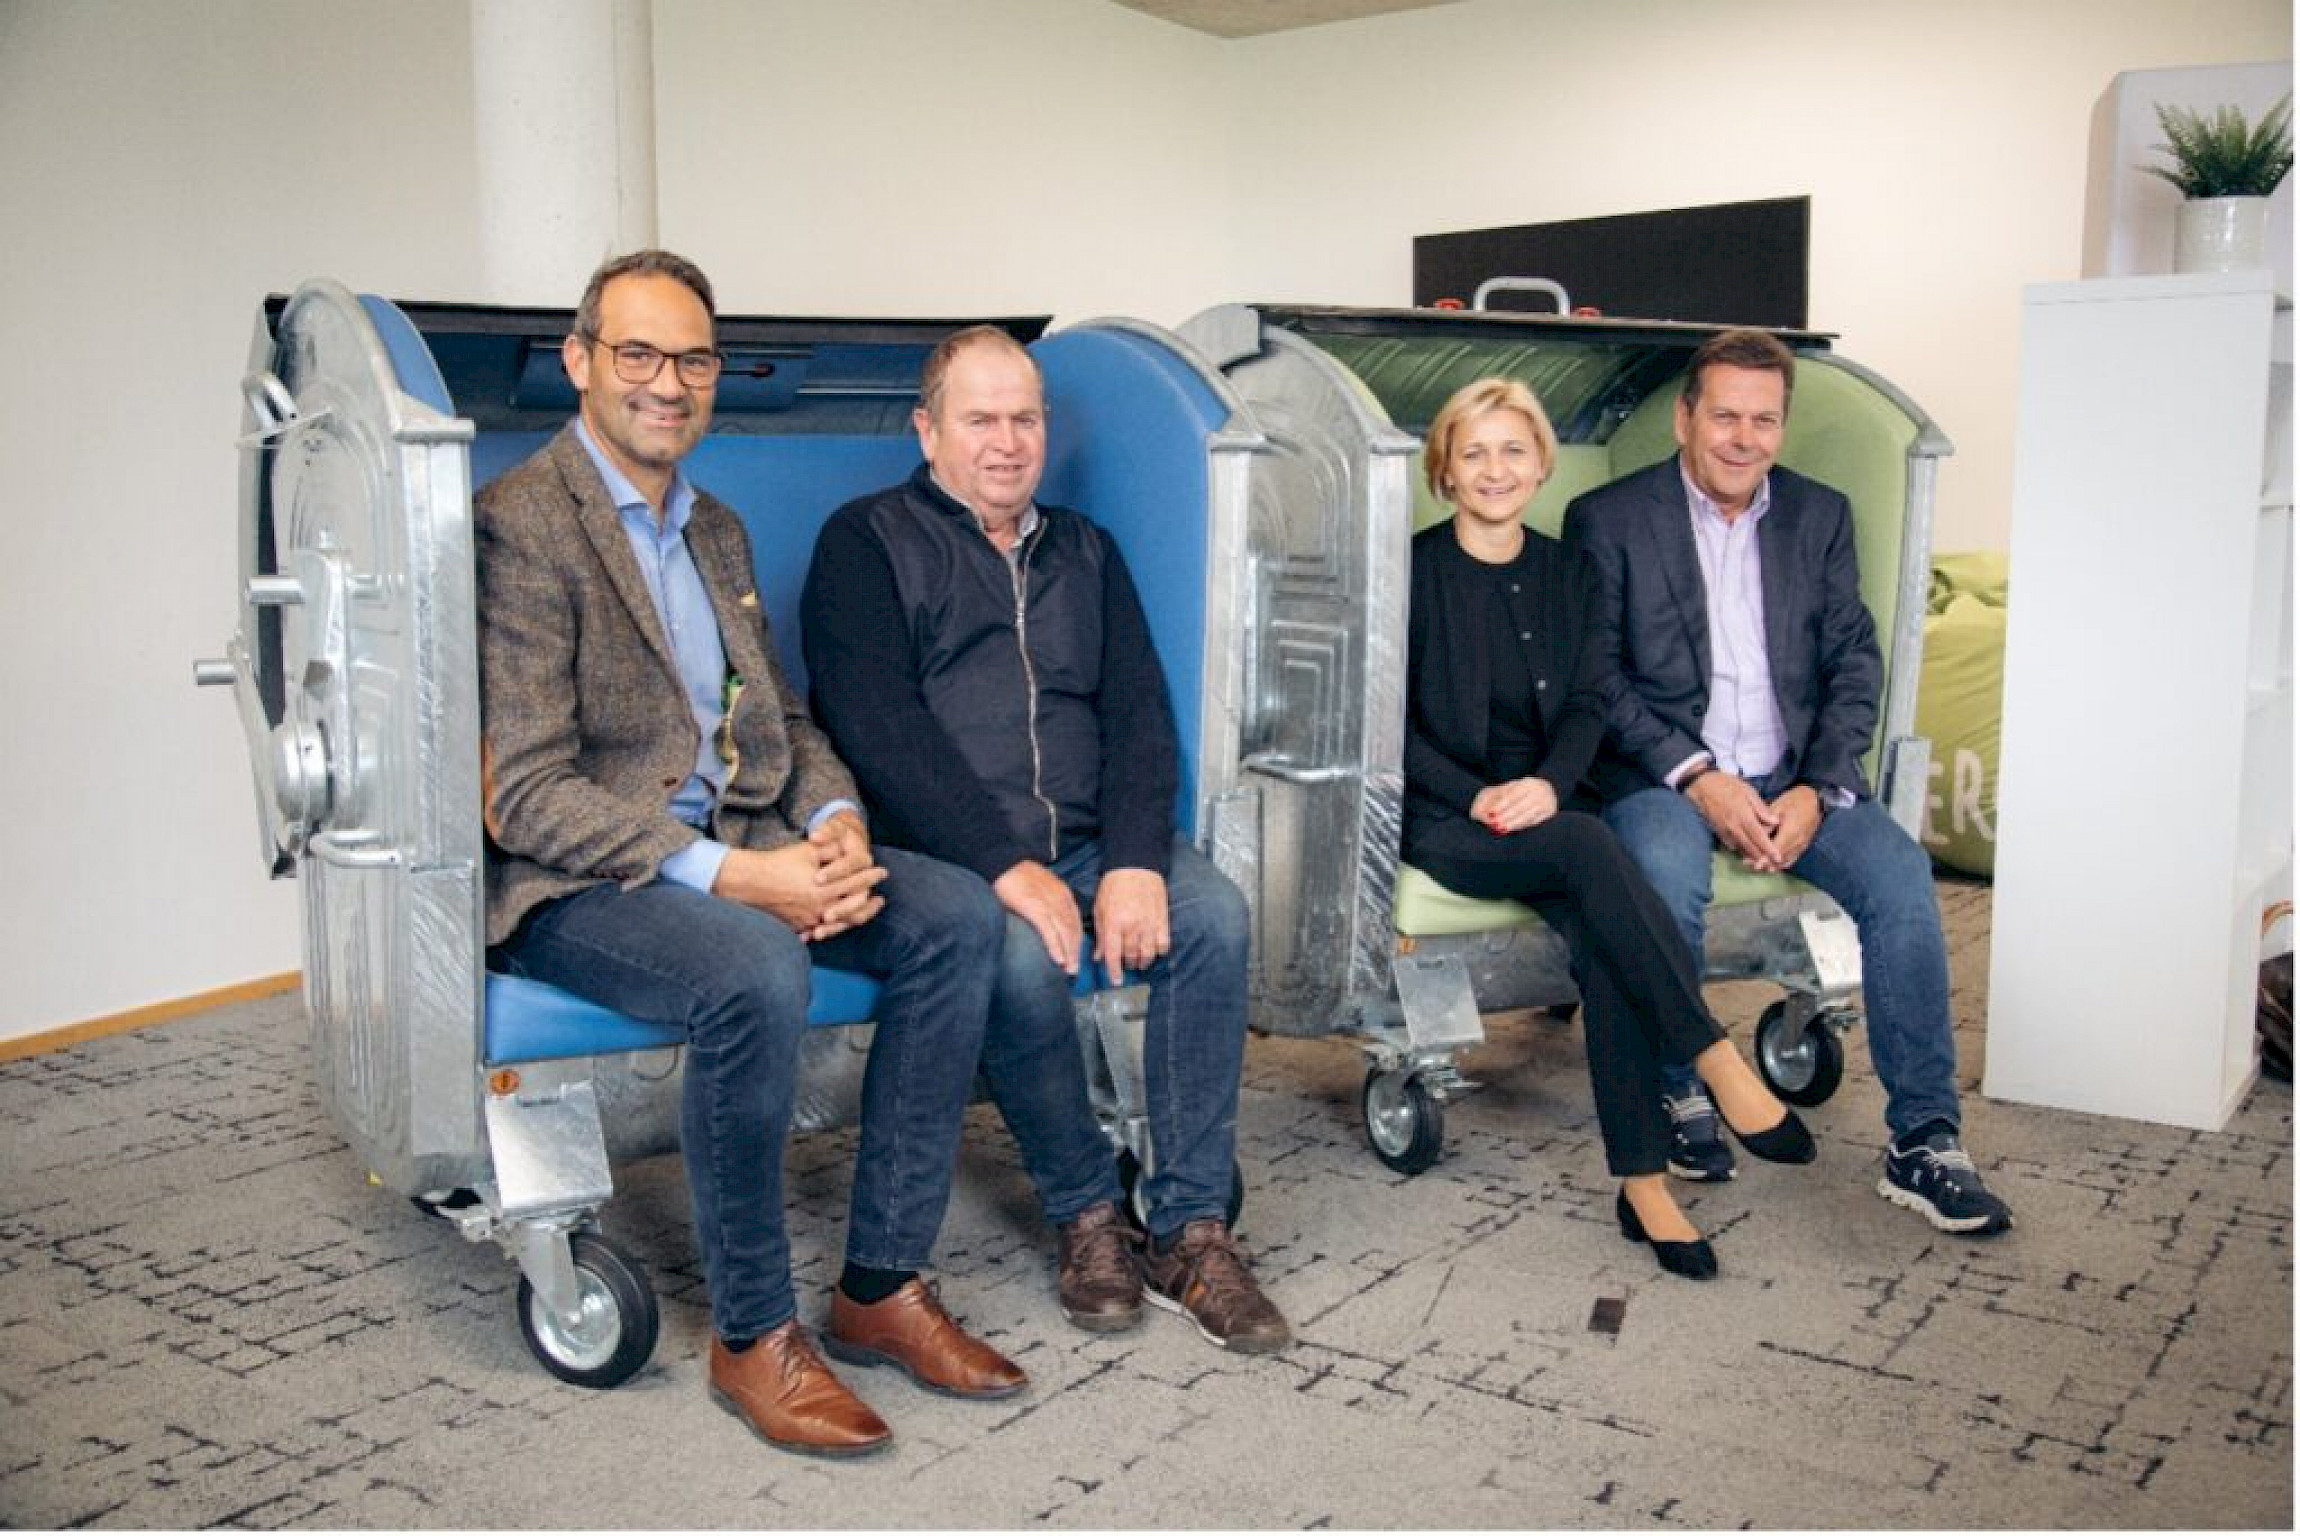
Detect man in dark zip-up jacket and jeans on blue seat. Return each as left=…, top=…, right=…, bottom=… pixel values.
left=800, top=327, right=1290, bottom=1352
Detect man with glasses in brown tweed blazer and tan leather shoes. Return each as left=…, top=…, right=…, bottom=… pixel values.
left=476, top=251, right=1026, bottom=1456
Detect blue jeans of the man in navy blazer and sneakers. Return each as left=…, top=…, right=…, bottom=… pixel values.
left=1605, top=782, right=1960, bottom=1138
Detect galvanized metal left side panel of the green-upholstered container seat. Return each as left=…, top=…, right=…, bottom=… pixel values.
left=1182, top=306, right=1417, bottom=1035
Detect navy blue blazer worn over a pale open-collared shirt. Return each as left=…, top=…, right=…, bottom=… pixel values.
left=1564, top=455, right=1884, bottom=800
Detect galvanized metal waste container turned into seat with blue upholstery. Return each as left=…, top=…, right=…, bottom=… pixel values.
left=198, top=281, right=1258, bottom=1387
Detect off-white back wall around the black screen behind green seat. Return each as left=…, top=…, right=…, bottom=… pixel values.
left=1226, top=0, right=2291, bottom=550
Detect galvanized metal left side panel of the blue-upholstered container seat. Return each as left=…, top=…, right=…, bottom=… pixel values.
left=217, top=283, right=488, bottom=1193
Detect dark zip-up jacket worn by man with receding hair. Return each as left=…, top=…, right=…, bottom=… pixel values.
left=800, top=464, right=1180, bottom=881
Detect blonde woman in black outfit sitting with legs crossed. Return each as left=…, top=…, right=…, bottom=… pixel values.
left=1403, top=379, right=1815, bottom=1281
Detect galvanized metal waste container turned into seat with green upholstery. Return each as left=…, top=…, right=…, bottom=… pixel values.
left=1180, top=304, right=1950, bottom=1170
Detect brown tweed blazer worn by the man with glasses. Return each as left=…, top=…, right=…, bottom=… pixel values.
left=474, top=425, right=860, bottom=945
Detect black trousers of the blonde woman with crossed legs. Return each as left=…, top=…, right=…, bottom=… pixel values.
left=1405, top=812, right=1725, bottom=1177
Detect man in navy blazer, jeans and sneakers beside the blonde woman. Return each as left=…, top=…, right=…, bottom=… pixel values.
left=1566, top=331, right=2013, bottom=1237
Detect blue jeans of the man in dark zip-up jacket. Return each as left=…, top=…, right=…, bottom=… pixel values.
left=982, top=839, right=1247, bottom=1237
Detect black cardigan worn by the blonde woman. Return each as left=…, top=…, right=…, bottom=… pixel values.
left=1405, top=520, right=1605, bottom=855
